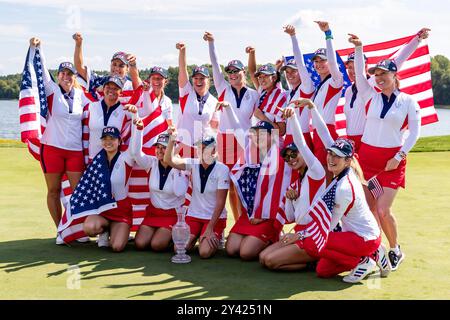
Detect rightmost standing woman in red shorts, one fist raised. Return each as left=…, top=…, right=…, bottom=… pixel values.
left=349, top=35, right=421, bottom=270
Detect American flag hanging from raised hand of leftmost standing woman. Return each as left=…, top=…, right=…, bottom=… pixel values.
left=19, top=47, right=72, bottom=210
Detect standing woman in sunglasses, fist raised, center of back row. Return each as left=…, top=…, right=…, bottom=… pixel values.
left=203, top=32, right=269, bottom=220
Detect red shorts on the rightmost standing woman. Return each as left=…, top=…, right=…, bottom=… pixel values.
left=359, top=142, right=406, bottom=189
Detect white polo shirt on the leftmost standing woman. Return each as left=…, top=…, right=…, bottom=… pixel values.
left=41, top=81, right=90, bottom=151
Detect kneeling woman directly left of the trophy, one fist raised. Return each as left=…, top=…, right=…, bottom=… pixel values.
left=130, top=120, right=189, bottom=251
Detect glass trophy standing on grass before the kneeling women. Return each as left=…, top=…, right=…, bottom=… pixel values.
left=172, top=207, right=191, bottom=263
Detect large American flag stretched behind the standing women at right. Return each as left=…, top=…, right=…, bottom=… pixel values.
left=286, top=35, right=438, bottom=136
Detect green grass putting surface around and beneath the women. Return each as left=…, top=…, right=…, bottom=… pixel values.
left=0, top=148, right=450, bottom=300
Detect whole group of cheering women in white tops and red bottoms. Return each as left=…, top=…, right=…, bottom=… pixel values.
left=26, top=21, right=429, bottom=283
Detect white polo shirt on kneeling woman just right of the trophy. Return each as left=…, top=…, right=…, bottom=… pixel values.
left=186, top=158, right=230, bottom=220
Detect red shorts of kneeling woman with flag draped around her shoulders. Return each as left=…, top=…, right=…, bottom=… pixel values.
left=230, top=214, right=282, bottom=243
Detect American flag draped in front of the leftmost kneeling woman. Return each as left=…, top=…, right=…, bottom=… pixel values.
left=58, top=150, right=117, bottom=243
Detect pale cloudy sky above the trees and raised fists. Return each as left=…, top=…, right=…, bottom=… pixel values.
left=0, top=0, right=450, bottom=75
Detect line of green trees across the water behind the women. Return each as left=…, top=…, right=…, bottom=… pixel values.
left=0, top=55, right=450, bottom=105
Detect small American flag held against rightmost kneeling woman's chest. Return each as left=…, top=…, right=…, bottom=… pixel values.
left=305, top=180, right=337, bottom=252
